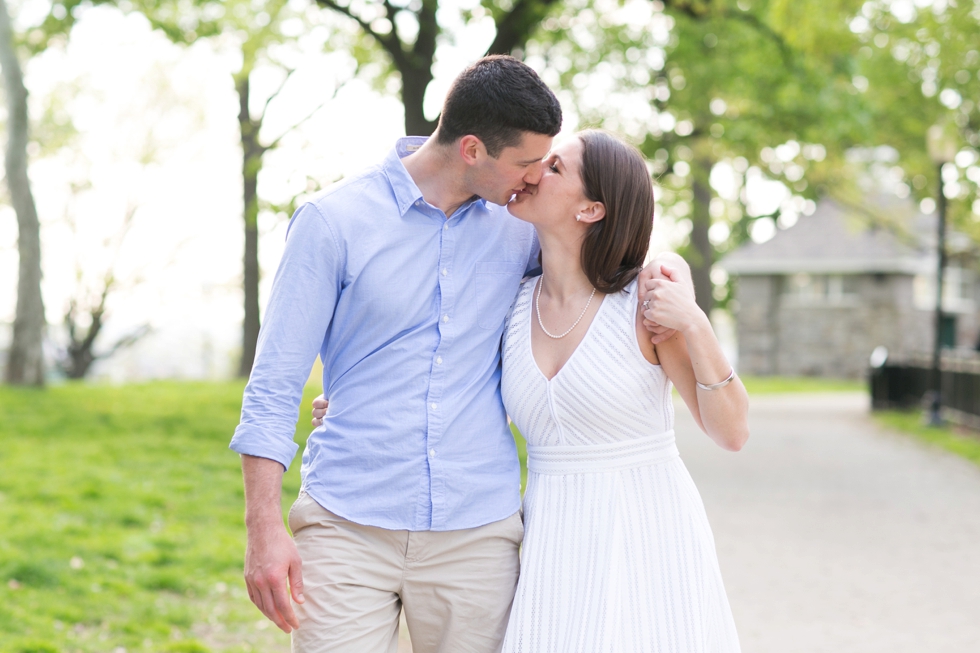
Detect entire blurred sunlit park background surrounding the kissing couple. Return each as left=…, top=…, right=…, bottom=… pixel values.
left=0, top=0, right=980, bottom=653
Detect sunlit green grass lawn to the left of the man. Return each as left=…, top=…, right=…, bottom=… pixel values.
left=0, top=382, right=322, bottom=653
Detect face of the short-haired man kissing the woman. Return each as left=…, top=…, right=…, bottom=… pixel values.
left=471, top=132, right=552, bottom=206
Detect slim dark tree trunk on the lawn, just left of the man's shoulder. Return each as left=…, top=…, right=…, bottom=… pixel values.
left=235, top=70, right=265, bottom=378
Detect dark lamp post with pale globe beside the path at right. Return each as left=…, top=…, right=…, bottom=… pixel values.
left=926, top=125, right=956, bottom=426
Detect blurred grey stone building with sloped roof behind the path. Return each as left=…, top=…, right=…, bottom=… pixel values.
left=719, top=197, right=980, bottom=378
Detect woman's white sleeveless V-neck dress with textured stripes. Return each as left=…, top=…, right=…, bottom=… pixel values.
left=502, top=278, right=739, bottom=653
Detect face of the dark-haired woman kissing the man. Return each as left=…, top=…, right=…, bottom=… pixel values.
left=507, top=137, right=591, bottom=226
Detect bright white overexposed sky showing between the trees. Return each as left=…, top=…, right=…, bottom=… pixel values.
left=0, top=0, right=940, bottom=381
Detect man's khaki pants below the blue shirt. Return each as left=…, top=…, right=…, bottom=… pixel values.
left=289, top=492, right=524, bottom=653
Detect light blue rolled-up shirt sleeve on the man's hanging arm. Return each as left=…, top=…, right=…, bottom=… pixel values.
left=229, top=204, right=344, bottom=469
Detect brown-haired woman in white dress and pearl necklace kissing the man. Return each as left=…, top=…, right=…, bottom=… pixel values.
left=502, top=131, right=748, bottom=653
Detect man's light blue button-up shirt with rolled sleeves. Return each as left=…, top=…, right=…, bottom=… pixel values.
left=231, top=137, right=538, bottom=531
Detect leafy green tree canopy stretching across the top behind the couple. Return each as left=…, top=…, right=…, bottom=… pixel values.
left=7, top=0, right=980, bottom=374
